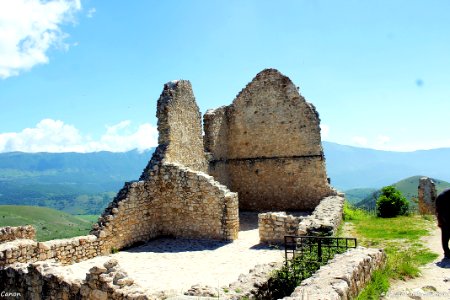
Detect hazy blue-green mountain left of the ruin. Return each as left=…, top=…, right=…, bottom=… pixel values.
left=0, top=149, right=153, bottom=214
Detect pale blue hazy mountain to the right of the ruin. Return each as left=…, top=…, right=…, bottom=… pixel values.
left=322, top=142, right=450, bottom=190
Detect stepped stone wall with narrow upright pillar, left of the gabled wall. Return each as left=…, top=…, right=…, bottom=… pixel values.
left=92, top=80, right=239, bottom=249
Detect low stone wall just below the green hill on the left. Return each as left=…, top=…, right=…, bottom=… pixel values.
left=0, top=235, right=103, bottom=267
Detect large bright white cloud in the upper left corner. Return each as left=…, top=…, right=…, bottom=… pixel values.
left=0, top=0, right=81, bottom=78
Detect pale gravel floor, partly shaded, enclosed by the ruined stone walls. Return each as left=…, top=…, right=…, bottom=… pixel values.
left=55, top=213, right=284, bottom=295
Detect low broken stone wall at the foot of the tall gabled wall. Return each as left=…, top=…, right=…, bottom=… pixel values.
left=258, top=194, right=344, bottom=244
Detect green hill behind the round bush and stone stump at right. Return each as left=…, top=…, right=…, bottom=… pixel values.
left=356, top=175, right=450, bottom=209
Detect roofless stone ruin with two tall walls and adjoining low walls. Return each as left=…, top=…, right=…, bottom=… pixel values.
left=0, top=69, right=364, bottom=299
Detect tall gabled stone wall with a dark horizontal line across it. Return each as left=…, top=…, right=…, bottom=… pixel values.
left=204, top=69, right=334, bottom=211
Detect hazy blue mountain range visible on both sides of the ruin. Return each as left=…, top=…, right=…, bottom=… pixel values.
left=0, top=142, right=450, bottom=214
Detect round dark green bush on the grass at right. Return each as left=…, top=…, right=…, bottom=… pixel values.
left=377, top=186, right=409, bottom=218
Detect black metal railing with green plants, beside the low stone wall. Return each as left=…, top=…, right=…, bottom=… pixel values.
left=284, top=235, right=358, bottom=263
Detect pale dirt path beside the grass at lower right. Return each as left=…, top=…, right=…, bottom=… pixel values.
left=384, top=228, right=450, bottom=300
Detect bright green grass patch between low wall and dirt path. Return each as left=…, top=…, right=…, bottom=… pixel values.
left=341, top=203, right=438, bottom=299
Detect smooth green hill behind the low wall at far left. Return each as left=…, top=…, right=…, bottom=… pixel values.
left=0, top=205, right=97, bottom=241
